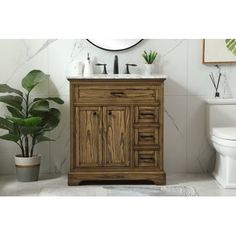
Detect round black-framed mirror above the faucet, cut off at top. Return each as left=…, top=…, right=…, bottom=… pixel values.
left=87, top=39, right=142, bottom=51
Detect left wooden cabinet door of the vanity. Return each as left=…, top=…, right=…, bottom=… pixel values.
left=75, top=107, right=102, bottom=167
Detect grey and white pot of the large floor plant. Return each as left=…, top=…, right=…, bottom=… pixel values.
left=15, top=155, right=41, bottom=182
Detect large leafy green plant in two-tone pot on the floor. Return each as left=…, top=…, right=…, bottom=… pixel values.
left=0, top=70, right=64, bottom=182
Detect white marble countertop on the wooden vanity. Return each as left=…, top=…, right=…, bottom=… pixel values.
left=67, top=74, right=167, bottom=79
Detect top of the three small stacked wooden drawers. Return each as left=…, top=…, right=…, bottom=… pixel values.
left=135, top=106, right=160, bottom=123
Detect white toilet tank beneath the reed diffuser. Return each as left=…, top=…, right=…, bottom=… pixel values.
left=207, top=98, right=236, bottom=135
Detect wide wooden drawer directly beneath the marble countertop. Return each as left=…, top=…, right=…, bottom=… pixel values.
left=73, top=85, right=160, bottom=103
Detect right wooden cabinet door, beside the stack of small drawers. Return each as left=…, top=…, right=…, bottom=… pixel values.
left=103, top=106, right=131, bottom=167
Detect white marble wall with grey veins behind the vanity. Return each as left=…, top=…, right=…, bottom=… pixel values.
left=0, top=39, right=236, bottom=174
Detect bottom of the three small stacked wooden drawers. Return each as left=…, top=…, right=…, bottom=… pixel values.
left=135, top=150, right=160, bottom=168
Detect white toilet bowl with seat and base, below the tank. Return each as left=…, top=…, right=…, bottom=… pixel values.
left=211, top=127, right=236, bottom=188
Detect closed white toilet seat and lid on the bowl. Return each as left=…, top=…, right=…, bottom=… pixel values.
left=211, top=127, right=236, bottom=147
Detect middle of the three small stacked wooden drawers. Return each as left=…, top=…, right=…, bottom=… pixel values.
left=134, top=128, right=159, bottom=146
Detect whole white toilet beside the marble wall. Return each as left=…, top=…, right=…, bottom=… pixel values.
left=207, top=98, right=236, bottom=188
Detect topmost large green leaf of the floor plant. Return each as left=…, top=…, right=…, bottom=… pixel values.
left=21, top=70, right=49, bottom=92
